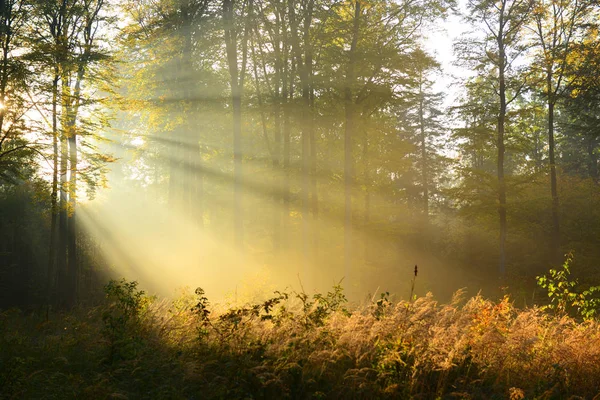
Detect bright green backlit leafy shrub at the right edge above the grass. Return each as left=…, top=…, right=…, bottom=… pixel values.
left=536, top=253, right=600, bottom=320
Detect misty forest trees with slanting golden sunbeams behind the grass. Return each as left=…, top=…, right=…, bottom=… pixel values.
left=0, top=0, right=600, bottom=305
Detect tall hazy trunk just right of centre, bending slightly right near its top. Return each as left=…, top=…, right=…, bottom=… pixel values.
left=344, top=0, right=361, bottom=283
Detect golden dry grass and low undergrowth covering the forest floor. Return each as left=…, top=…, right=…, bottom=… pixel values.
left=0, top=281, right=600, bottom=399
